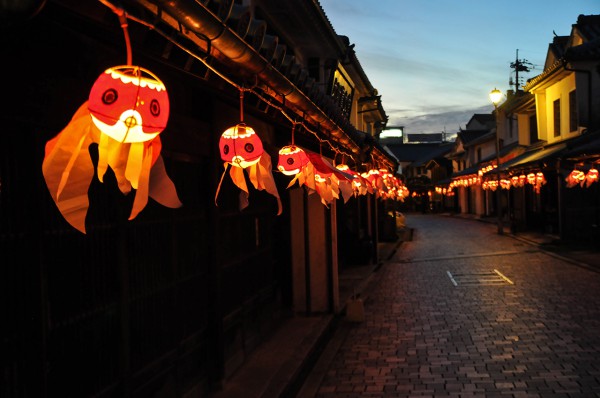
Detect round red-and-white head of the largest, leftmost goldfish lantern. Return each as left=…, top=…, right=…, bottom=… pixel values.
left=88, top=66, right=169, bottom=143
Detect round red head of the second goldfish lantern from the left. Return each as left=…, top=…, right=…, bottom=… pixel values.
left=219, top=123, right=264, bottom=169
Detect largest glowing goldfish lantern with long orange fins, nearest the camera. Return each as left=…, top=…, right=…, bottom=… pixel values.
left=42, top=65, right=181, bottom=233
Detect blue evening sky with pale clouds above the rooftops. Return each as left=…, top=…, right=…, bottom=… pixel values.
left=319, top=0, right=600, bottom=134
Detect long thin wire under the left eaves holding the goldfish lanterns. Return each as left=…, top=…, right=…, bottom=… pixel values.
left=99, top=0, right=355, bottom=160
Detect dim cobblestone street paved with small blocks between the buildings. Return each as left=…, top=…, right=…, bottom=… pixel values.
left=299, top=214, right=600, bottom=398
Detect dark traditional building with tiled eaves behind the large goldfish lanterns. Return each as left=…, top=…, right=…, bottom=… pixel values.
left=0, top=0, right=404, bottom=397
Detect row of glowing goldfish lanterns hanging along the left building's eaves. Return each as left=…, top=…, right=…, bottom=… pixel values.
left=42, top=8, right=408, bottom=233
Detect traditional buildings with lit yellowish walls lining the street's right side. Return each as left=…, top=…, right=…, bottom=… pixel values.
left=436, top=15, right=600, bottom=240
